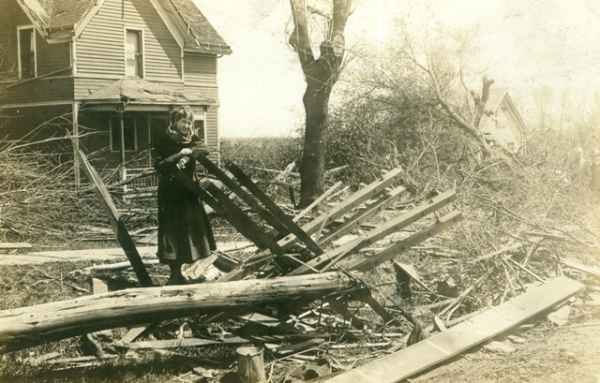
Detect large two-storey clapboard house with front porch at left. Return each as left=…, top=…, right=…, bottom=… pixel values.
left=0, top=0, right=231, bottom=186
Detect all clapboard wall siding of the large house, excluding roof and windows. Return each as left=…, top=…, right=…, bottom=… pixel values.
left=0, top=0, right=219, bottom=164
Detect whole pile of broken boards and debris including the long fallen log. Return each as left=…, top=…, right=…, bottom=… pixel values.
left=0, top=153, right=592, bottom=382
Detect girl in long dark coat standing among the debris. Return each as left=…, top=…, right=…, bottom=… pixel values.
left=155, top=106, right=216, bottom=284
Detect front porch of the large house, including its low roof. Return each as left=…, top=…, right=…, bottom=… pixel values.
left=73, top=79, right=214, bottom=191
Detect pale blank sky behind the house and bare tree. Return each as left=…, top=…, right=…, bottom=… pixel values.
left=195, top=0, right=600, bottom=137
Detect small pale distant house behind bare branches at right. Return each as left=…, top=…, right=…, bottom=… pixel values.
left=480, top=87, right=527, bottom=152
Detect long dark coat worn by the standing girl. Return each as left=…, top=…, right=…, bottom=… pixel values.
left=155, top=137, right=216, bottom=264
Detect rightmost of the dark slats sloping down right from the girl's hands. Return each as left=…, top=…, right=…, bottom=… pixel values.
left=227, top=162, right=323, bottom=255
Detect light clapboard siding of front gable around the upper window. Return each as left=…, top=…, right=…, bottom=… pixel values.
left=76, top=0, right=181, bottom=81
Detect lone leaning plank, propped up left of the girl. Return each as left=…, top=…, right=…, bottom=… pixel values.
left=79, top=150, right=153, bottom=287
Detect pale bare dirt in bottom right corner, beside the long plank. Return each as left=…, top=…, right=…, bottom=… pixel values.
left=410, top=320, right=600, bottom=383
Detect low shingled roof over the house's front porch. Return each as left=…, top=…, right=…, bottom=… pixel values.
left=81, top=79, right=215, bottom=105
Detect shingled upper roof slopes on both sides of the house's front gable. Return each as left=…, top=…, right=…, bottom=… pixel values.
left=17, top=0, right=231, bottom=54
